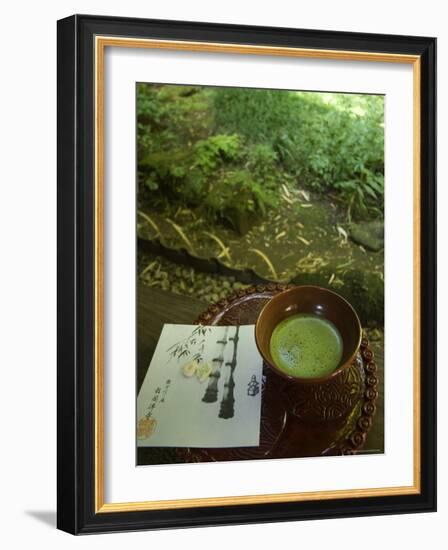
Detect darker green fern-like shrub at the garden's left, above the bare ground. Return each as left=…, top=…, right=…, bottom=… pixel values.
left=140, top=134, right=275, bottom=226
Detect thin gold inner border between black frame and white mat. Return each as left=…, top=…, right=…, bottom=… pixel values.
left=94, top=36, right=421, bottom=513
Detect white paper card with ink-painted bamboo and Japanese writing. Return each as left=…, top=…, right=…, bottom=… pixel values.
left=137, top=324, right=263, bottom=447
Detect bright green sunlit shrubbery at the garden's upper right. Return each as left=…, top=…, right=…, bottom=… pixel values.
left=213, top=88, right=384, bottom=222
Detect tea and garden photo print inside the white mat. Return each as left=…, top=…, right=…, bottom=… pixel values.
left=135, top=82, right=388, bottom=466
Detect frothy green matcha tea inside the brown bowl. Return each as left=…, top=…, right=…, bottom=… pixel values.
left=270, top=313, right=343, bottom=378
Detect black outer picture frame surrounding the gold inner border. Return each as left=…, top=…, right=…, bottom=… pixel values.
left=57, top=15, right=436, bottom=534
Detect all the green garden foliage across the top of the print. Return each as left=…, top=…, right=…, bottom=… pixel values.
left=137, top=84, right=384, bottom=222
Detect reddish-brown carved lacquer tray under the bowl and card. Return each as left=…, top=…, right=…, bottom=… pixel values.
left=178, top=284, right=378, bottom=462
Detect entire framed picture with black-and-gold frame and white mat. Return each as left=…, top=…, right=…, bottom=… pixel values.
left=58, top=15, right=436, bottom=534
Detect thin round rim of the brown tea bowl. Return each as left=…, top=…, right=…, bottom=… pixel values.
left=255, top=285, right=362, bottom=384
